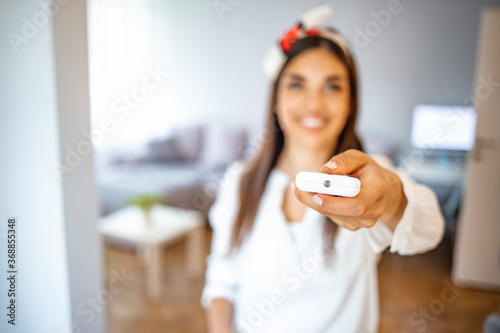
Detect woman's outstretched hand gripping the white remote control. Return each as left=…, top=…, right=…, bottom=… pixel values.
left=292, top=149, right=407, bottom=231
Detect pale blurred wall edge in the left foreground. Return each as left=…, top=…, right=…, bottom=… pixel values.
left=0, top=0, right=105, bottom=333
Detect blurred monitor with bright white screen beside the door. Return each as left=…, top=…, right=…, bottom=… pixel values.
left=411, top=104, right=476, bottom=151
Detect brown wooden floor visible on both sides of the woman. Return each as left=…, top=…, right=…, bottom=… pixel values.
left=106, top=228, right=500, bottom=333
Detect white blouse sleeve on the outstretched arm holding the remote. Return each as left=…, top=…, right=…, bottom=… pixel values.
left=362, top=155, right=444, bottom=255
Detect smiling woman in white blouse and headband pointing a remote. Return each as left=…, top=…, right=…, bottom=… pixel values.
left=201, top=5, right=444, bottom=333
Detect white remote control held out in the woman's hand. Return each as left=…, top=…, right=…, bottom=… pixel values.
left=295, top=171, right=361, bottom=197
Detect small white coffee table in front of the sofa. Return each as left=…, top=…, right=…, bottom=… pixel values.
left=98, top=205, right=204, bottom=300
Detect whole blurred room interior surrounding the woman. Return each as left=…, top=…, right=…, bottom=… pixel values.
left=0, top=0, right=500, bottom=333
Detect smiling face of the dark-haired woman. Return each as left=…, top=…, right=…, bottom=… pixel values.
left=276, top=48, right=351, bottom=150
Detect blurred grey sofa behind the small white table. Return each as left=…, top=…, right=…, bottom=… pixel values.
left=96, top=125, right=247, bottom=215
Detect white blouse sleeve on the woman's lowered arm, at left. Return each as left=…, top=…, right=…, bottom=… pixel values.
left=201, top=163, right=243, bottom=308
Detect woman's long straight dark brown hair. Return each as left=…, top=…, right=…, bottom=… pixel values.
left=231, top=30, right=362, bottom=255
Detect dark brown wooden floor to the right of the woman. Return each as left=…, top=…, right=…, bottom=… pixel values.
left=379, top=233, right=500, bottom=333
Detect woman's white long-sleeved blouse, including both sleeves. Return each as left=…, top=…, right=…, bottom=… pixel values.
left=201, top=155, right=444, bottom=333
